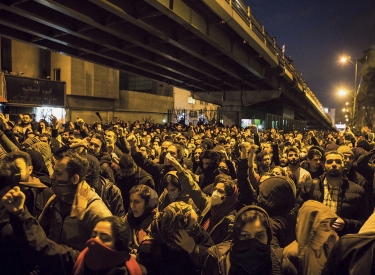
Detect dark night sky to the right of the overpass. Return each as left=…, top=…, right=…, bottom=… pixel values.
left=244, top=0, right=375, bottom=111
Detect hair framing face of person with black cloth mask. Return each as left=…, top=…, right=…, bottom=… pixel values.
left=233, top=209, right=272, bottom=243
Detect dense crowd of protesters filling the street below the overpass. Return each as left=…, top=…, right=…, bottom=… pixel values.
left=0, top=114, right=375, bottom=275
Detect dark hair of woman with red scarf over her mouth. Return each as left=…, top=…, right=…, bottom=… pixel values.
left=99, top=216, right=131, bottom=251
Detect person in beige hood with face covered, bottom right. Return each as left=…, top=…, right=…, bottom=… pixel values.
left=283, top=200, right=338, bottom=275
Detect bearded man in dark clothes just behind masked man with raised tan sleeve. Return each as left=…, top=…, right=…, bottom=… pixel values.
left=88, top=134, right=115, bottom=182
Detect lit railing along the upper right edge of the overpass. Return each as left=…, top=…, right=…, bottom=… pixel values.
left=226, top=0, right=330, bottom=123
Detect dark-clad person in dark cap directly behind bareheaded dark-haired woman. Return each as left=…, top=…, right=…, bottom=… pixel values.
left=115, top=154, right=155, bottom=213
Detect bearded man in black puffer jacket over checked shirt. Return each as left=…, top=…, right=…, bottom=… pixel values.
left=297, top=151, right=369, bottom=236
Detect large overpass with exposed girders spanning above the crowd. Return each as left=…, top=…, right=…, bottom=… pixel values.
left=0, top=0, right=332, bottom=129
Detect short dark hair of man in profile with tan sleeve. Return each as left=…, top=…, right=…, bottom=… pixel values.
left=55, top=150, right=89, bottom=181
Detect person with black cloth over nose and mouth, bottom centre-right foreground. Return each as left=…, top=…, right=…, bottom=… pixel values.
left=202, top=205, right=283, bottom=275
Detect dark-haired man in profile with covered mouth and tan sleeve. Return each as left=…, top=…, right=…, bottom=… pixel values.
left=39, top=151, right=112, bottom=250
